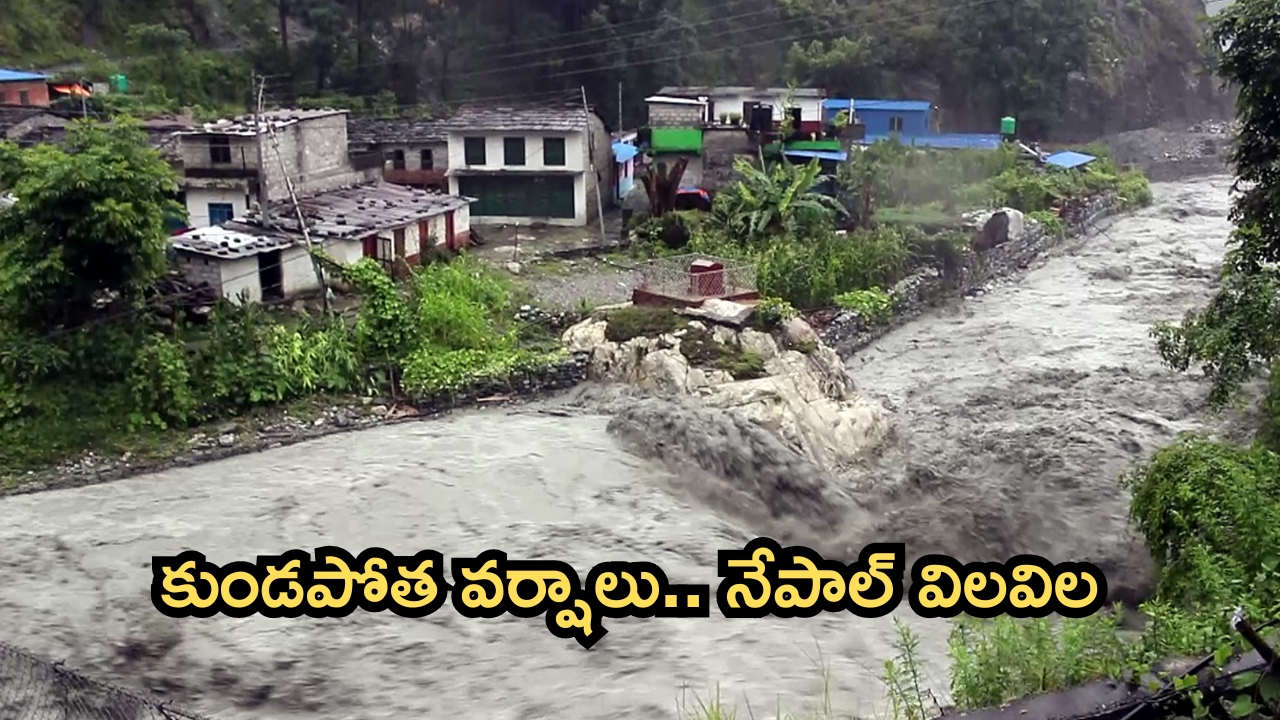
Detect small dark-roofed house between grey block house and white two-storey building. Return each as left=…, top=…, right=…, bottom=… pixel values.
left=347, top=118, right=449, bottom=192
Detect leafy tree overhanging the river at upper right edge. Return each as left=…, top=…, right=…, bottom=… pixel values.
left=1153, top=0, right=1280, bottom=404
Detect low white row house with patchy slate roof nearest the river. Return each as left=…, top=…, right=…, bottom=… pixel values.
left=170, top=182, right=471, bottom=304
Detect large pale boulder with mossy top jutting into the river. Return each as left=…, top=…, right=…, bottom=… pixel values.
left=562, top=307, right=896, bottom=469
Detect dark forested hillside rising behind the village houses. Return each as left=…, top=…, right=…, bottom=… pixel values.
left=0, top=0, right=1226, bottom=138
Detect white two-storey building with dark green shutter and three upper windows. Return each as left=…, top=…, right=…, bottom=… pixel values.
left=448, top=105, right=613, bottom=225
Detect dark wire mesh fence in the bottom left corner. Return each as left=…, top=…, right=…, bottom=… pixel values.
left=0, top=642, right=207, bottom=720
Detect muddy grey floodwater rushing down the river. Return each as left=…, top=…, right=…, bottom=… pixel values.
left=0, top=178, right=1229, bottom=720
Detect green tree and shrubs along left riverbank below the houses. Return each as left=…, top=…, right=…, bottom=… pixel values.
left=0, top=122, right=558, bottom=480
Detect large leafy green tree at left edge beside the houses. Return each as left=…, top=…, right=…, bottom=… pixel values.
left=0, top=120, right=183, bottom=332
